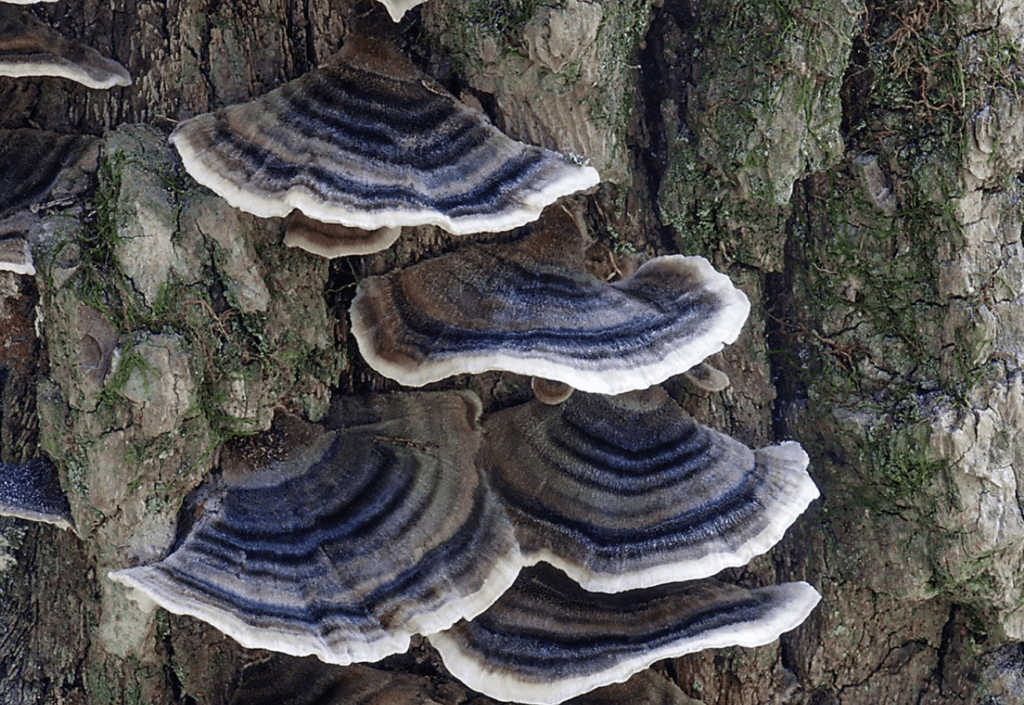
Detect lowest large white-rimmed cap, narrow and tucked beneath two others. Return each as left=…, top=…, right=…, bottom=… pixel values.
left=428, top=566, right=820, bottom=703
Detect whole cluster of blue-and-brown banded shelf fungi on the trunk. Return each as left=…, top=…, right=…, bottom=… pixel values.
left=0, top=5, right=819, bottom=703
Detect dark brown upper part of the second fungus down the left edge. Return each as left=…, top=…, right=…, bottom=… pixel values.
left=0, top=126, right=96, bottom=216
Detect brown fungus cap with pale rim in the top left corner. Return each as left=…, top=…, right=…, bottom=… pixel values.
left=0, top=4, right=131, bottom=88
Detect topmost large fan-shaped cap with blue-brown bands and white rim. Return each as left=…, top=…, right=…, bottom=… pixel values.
left=171, top=38, right=599, bottom=235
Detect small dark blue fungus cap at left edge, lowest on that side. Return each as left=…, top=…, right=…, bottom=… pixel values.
left=0, top=459, right=75, bottom=529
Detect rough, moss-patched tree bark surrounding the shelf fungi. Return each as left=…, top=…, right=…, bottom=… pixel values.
left=6, top=0, right=1024, bottom=705
